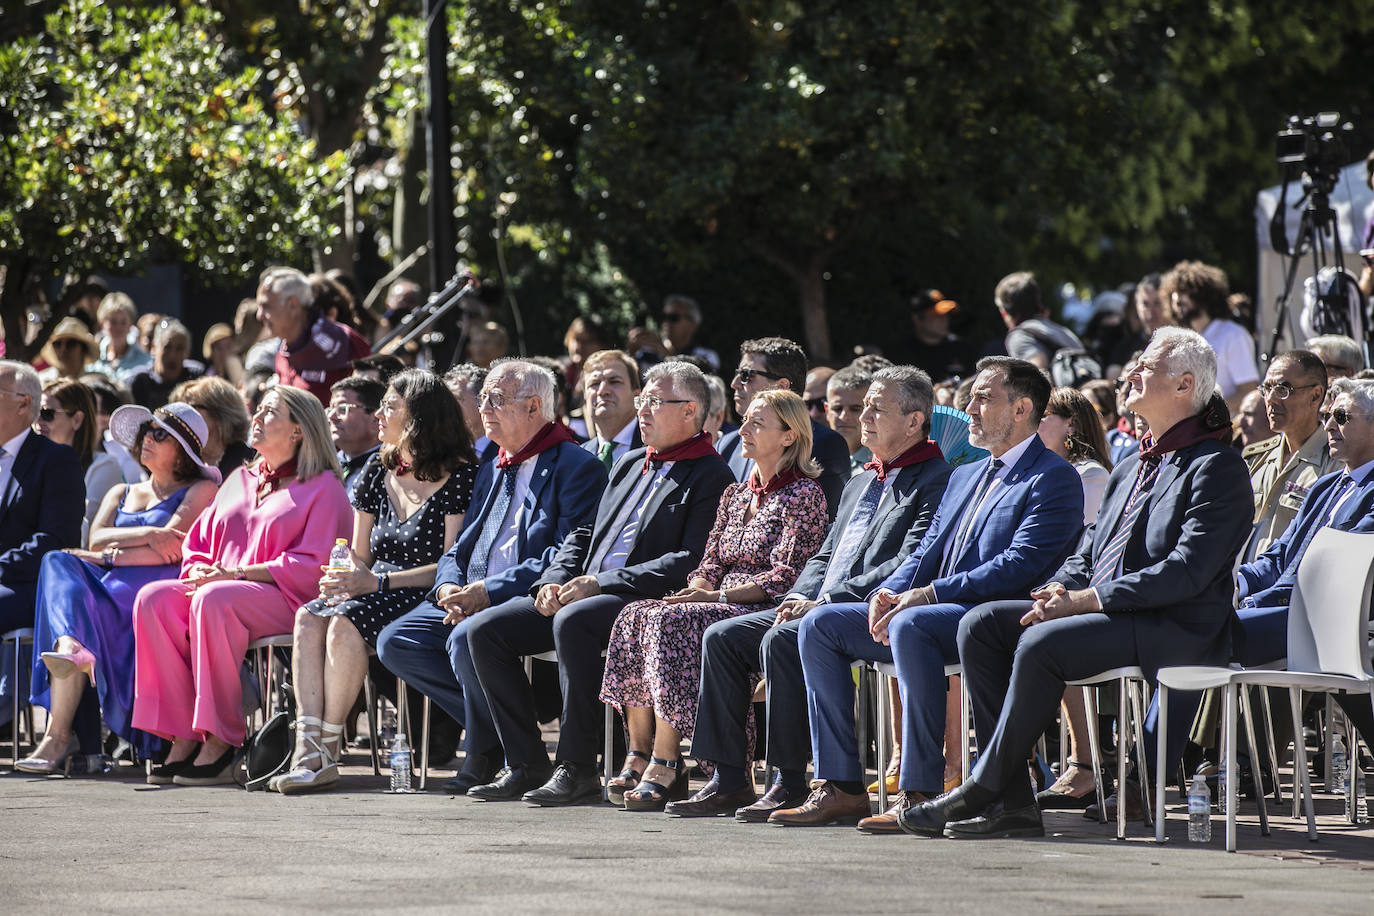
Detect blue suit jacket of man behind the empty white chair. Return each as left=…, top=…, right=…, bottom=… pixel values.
left=1239, top=471, right=1374, bottom=607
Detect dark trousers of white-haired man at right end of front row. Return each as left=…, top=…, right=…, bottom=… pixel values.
left=959, top=602, right=1202, bottom=808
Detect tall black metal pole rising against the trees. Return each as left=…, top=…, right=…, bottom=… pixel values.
left=425, top=0, right=458, bottom=290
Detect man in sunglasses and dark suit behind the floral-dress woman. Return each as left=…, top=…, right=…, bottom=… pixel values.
left=717, top=336, right=849, bottom=522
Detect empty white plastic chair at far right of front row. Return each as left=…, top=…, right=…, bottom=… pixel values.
left=1154, top=527, right=1374, bottom=853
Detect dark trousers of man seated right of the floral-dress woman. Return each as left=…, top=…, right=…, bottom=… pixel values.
left=691, top=610, right=811, bottom=770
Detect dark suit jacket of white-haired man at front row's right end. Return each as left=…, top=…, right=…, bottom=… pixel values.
left=1054, top=439, right=1258, bottom=676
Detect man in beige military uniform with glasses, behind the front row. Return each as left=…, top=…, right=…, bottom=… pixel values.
left=1241, top=350, right=1336, bottom=559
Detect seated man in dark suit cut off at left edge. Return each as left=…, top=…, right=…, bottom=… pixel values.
left=0, top=360, right=85, bottom=724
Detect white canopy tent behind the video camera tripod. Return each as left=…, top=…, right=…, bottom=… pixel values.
left=1254, top=159, right=1374, bottom=359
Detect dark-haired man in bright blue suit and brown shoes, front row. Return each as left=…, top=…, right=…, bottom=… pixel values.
left=768, top=357, right=1083, bottom=832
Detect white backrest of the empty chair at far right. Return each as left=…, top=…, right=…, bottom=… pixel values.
left=1287, top=527, right=1374, bottom=680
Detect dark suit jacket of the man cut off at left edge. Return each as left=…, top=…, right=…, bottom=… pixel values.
left=0, top=433, right=85, bottom=590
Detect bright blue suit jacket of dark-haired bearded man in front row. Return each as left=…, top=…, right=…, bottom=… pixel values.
left=870, top=435, right=1083, bottom=607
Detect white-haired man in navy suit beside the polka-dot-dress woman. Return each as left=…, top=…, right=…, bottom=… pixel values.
left=376, top=360, right=606, bottom=791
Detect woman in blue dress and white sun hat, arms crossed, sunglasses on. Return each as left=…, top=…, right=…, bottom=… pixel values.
left=15, top=404, right=220, bottom=773
